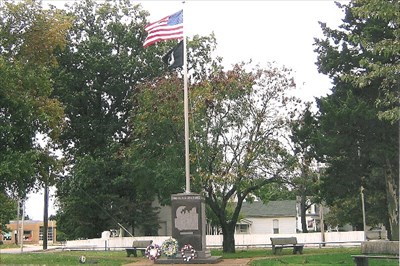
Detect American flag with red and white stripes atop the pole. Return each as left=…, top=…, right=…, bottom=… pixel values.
left=143, top=10, right=183, bottom=48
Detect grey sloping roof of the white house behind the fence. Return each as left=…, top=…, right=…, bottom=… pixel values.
left=241, top=200, right=297, bottom=218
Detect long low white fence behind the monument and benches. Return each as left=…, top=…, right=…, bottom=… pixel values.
left=65, top=231, right=364, bottom=250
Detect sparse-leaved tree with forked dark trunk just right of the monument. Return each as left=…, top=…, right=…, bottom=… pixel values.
left=191, top=61, right=297, bottom=252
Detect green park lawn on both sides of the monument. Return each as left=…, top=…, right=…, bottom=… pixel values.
left=0, top=244, right=399, bottom=266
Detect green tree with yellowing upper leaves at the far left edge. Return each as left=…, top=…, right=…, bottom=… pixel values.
left=0, top=1, right=70, bottom=212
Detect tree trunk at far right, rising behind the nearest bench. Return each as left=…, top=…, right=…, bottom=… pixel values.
left=385, top=158, right=399, bottom=241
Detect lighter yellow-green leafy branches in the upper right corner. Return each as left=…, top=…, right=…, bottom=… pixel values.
left=343, top=0, right=400, bottom=123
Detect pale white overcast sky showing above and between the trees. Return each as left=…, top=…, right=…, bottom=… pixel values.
left=26, top=0, right=348, bottom=220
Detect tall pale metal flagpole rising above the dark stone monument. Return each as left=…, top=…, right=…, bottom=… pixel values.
left=182, top=1, right=190, bottom=193
